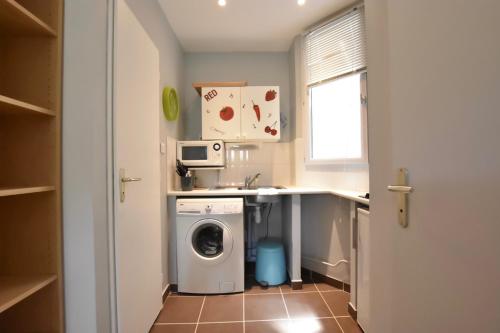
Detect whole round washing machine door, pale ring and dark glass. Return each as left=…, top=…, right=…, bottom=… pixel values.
left=185, top=219, right=233, bottom=265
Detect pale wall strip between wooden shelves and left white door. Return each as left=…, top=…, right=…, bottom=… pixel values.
left=62, top=0, right=111, bottom=333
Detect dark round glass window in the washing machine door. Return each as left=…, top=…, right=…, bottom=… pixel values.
left=192, top=223, right=224, bottom=258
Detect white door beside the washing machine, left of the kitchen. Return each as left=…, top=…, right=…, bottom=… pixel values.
left=114, top=0, right=162, bottom=333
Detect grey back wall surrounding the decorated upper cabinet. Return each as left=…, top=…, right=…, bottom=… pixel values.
left=183, top=52, right=292, bottom=142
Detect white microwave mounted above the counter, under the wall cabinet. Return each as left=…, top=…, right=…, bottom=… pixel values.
left=177, top=140, right=226, bottom=167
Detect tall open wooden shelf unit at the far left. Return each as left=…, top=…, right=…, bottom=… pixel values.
left=0, top=0, right=64, bottom=333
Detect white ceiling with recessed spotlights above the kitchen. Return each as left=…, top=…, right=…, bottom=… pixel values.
left=158, top=0, right=354, bottom=52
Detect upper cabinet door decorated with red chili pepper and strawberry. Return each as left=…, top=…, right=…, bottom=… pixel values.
left=241, top=86, right=281, bottom=141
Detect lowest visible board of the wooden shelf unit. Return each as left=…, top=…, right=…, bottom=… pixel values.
left=0, top=275, right=57, bottom=313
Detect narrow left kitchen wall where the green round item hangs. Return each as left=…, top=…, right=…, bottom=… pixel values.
left=126, top=0, right=184, bottom=288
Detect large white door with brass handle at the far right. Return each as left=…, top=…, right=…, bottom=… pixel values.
left=365, top=0, right=500, bottom=333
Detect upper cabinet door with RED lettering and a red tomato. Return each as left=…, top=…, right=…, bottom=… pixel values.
left=201, top=87, right=241, bottom=141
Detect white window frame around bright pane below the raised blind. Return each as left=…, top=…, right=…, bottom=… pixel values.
left=303, top=72, right=368, bottom=166
